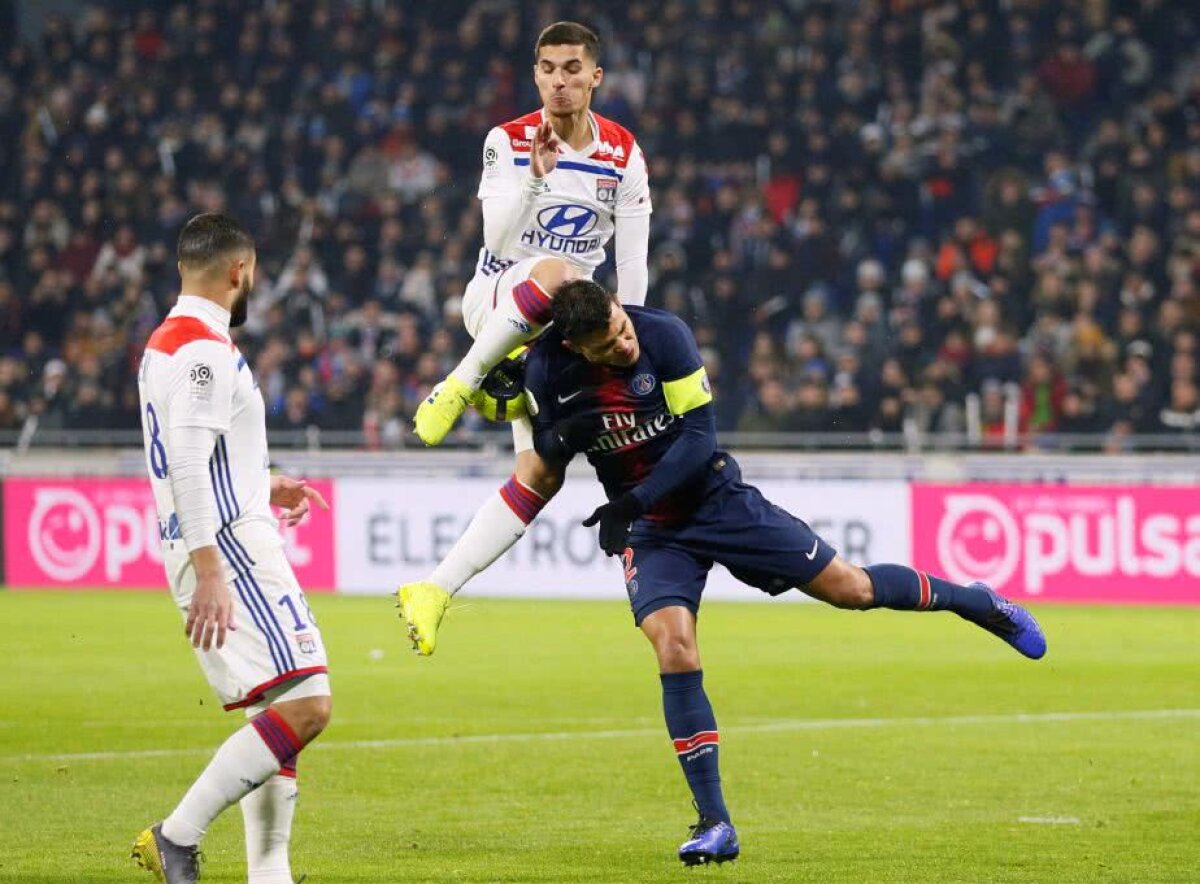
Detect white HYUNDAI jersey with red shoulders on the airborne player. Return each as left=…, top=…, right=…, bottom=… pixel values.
left=475, top=110, right=650, bottom=278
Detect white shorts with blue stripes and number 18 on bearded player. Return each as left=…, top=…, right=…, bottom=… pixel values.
left=163, top=522, right=328, bottom=709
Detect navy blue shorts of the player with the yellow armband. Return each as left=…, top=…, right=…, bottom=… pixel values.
left=623, top=458, right=836, bottom=626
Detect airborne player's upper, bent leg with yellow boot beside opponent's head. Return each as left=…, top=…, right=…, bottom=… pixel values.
left=413, top=258, right=577, bottom=445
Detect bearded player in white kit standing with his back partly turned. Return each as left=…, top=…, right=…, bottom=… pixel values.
left=133, top=214, right=330, bottom=884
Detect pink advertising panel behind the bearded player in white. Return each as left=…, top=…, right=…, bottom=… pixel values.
left=4, top=477, right=336, bottom=591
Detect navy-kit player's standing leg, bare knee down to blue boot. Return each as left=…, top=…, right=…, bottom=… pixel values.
left=641, top=605, right=739, bottom=866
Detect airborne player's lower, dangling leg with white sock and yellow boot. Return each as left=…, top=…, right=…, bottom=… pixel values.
left=396, top=448, right=563, bottom=656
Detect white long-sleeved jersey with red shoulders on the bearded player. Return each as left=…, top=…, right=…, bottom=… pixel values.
left=138, top=295, right=274, bottom=546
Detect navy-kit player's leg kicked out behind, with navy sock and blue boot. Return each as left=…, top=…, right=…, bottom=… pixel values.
left=804, top=558, right=1046, bottom=660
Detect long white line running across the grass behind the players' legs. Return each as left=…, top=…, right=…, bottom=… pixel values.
left=0, top=709, right=1200, bottom=762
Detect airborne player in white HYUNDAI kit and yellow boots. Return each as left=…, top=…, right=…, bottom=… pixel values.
left=397, top=22, right=650, bottom=654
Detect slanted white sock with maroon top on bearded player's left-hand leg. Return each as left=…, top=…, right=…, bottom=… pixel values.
left=162, top=712, right=300, bottom=847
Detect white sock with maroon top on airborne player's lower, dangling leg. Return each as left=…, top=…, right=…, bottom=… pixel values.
left=430, top=476, right=546, bottom=595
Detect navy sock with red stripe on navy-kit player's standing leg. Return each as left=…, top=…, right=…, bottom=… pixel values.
left=659, top=669, right=730, bottom=823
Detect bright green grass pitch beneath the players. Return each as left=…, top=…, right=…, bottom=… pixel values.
left=0, top=593, right=1200, bottom=884
